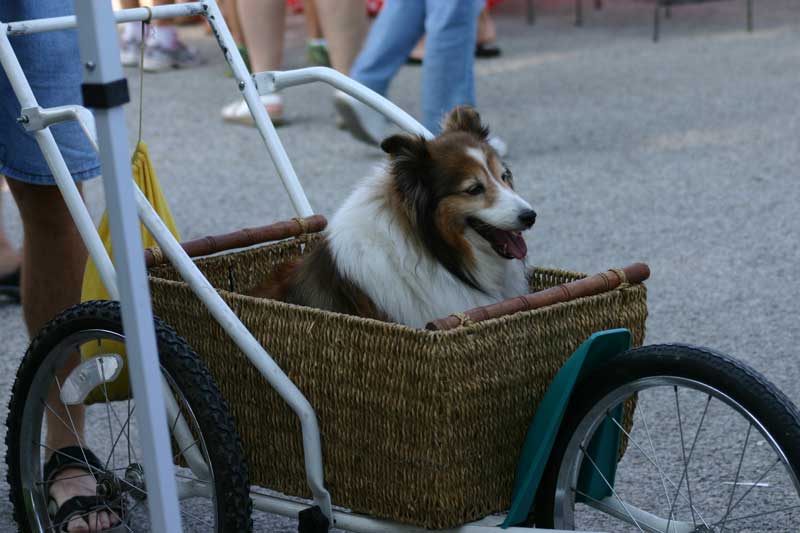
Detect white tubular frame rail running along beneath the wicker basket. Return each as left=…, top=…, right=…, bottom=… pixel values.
left=250, top=492, right=599, bottom=533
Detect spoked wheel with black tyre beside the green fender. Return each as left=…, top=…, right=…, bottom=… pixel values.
left=535, top=345, right=800, bottom=533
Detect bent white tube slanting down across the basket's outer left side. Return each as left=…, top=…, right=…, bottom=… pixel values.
left=135, top=187, right=333, bottom=523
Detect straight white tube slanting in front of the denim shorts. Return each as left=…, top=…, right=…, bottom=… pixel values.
left=0, top=23, right=119, bottom=300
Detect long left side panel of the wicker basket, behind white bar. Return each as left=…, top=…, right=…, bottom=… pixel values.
left=148, top=280, right=447, bottom=517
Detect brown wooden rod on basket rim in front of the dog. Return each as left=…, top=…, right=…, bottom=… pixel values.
left=425, top=263, right=650, bottom=331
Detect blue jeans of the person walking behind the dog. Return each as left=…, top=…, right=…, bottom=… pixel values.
left=350, top=0, right=485, bottom=134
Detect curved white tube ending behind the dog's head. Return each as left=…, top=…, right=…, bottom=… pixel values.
left=253, top=67, right=433, bottom=139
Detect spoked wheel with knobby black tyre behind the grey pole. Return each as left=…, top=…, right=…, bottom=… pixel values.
left=6, top=302, right=252, bottom=533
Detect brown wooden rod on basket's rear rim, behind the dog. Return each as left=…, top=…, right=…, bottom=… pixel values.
left=144, top=215, right=328, bottom=268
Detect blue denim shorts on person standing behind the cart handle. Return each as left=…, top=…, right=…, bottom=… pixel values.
left=0, top=0, right=100, bottom=185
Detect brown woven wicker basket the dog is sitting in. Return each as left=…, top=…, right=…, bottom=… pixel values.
left=151, top=231, right=647, bottom=528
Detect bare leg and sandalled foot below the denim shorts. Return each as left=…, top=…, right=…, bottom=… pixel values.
left=8, top=180, right=116, bottom=531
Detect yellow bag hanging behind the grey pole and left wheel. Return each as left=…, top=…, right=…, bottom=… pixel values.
left=81, top=141, right=180, bottom=403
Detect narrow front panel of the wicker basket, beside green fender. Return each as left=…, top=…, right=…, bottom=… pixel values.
left=425, top=285, right=647, bottom=527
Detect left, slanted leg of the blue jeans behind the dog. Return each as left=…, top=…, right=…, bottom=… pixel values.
left=350, top=0, right=424, bottom=95
